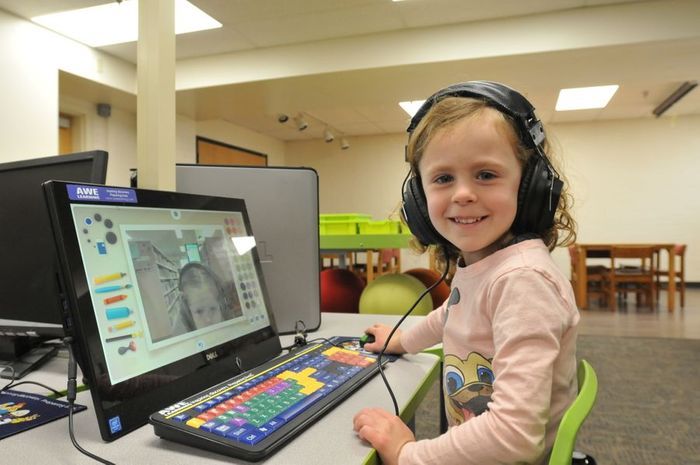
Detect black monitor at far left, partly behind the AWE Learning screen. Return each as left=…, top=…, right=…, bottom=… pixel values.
left=0, top=150, right=107, bottom=378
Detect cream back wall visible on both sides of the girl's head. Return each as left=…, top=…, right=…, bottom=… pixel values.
left=286, top=116, right=700, bottom=281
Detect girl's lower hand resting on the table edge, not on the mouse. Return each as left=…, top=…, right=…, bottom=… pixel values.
left=353, top=408, right=416, bottom=465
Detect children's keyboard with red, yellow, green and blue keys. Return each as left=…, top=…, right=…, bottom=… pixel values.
left=150, top=343, right=378, bottom=460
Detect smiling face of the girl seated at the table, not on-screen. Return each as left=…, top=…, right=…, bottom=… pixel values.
left=418, top=108, right=522, bottom=264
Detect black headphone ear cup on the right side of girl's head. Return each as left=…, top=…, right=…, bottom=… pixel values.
left=513, top=155, right=563, bottom=234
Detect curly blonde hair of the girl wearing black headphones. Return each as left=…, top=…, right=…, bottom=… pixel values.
left=406, top=97, right=576, bottom=270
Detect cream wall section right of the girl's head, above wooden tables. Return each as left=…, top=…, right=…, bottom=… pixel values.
left=550, top=115, right=700, bottom=281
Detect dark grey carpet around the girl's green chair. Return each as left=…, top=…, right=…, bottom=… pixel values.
left=416, top=336, right=700, bottom=465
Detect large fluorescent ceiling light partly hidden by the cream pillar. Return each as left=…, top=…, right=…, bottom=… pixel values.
left=32, top=0, right=221, bottom=47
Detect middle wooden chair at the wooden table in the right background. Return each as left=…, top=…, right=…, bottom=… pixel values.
left=606, top=246, right=656, bottom=311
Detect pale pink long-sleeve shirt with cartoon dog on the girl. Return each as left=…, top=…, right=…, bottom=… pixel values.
left=399, top=239, right=579, bottom=465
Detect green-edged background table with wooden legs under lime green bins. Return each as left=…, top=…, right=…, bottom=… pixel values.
left=319, top=234, right=413, bottom=282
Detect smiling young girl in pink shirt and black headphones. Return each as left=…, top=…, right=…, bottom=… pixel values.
left=353, top=81, right=579, bottom=465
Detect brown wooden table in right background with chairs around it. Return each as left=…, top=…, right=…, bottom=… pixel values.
left=574, top=243, right=676, bottom=312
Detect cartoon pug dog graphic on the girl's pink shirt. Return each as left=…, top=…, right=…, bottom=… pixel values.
left=444, top=352, right=494, bottom=425
